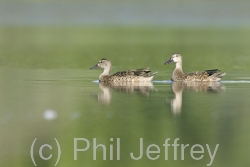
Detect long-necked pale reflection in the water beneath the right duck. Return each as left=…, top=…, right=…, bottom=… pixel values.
left=171, top=82, right=225, bottom=115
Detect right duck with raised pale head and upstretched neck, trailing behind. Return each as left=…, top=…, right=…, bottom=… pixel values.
left=165, top=54, right=226, bottom=82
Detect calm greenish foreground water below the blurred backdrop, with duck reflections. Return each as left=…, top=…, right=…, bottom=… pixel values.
left=0, top=68, right=250, bottom=167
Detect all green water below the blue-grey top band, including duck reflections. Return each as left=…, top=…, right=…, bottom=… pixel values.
left=0, top=27, right=250, bottom=167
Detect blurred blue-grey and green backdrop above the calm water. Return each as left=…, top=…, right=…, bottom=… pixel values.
left=0, top=0, right=250, bottom=75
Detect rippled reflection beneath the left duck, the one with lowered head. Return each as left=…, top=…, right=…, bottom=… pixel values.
left=97, top=82, right=154, bottom=104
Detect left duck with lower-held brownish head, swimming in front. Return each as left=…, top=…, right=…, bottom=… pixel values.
left=90, top=58, right=157, bottom=82
